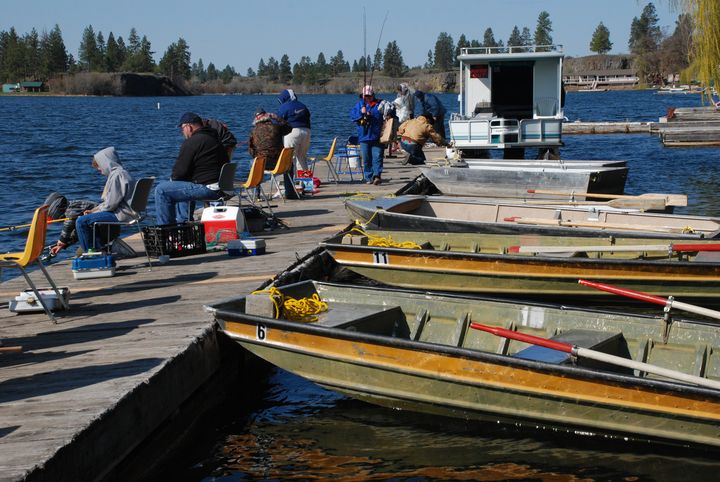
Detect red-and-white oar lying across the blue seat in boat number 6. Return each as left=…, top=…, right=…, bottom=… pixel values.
left=470, top=323, right=720, bottom=390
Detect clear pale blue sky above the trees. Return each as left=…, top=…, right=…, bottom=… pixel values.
left=0, top=0, right=679, bottom=75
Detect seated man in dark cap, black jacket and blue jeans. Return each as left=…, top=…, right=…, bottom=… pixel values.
left=155, top=112, right=228, bottom=224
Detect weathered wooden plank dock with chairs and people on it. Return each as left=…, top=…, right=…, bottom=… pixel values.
left=0, top=159, right=419, bottom=481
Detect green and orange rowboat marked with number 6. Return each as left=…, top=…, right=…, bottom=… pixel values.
left=206, top=281, right=720, bottom=449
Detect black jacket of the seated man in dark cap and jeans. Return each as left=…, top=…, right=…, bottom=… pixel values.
left=172, top=126, right=228, bottom=184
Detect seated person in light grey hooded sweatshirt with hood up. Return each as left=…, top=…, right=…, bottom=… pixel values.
left=75, top=147, right=135, bottom=252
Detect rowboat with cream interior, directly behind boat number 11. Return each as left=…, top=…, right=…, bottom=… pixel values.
left=345, top=195, right=720, bottom=239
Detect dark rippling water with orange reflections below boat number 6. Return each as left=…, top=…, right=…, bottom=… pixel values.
left=198, top=369, right=718, bottom=481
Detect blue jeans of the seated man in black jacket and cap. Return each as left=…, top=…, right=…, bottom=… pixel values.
left=155, top=181, right=222, bottom=224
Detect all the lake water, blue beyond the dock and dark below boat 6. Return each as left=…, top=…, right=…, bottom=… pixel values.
left=0, top=91, right=720, bottom=481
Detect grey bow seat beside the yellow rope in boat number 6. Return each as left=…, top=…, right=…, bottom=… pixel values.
left=313, top=303, right=407, bottom=336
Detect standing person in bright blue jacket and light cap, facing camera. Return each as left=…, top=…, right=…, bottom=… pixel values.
left=350, top=85, right=385, bottom=185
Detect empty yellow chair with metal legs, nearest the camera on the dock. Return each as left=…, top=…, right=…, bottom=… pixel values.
left=0, top=206, right=70, bottom=323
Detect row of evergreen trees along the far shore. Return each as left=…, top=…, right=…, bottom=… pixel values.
left=0, top=3, right=693, bottom=85
